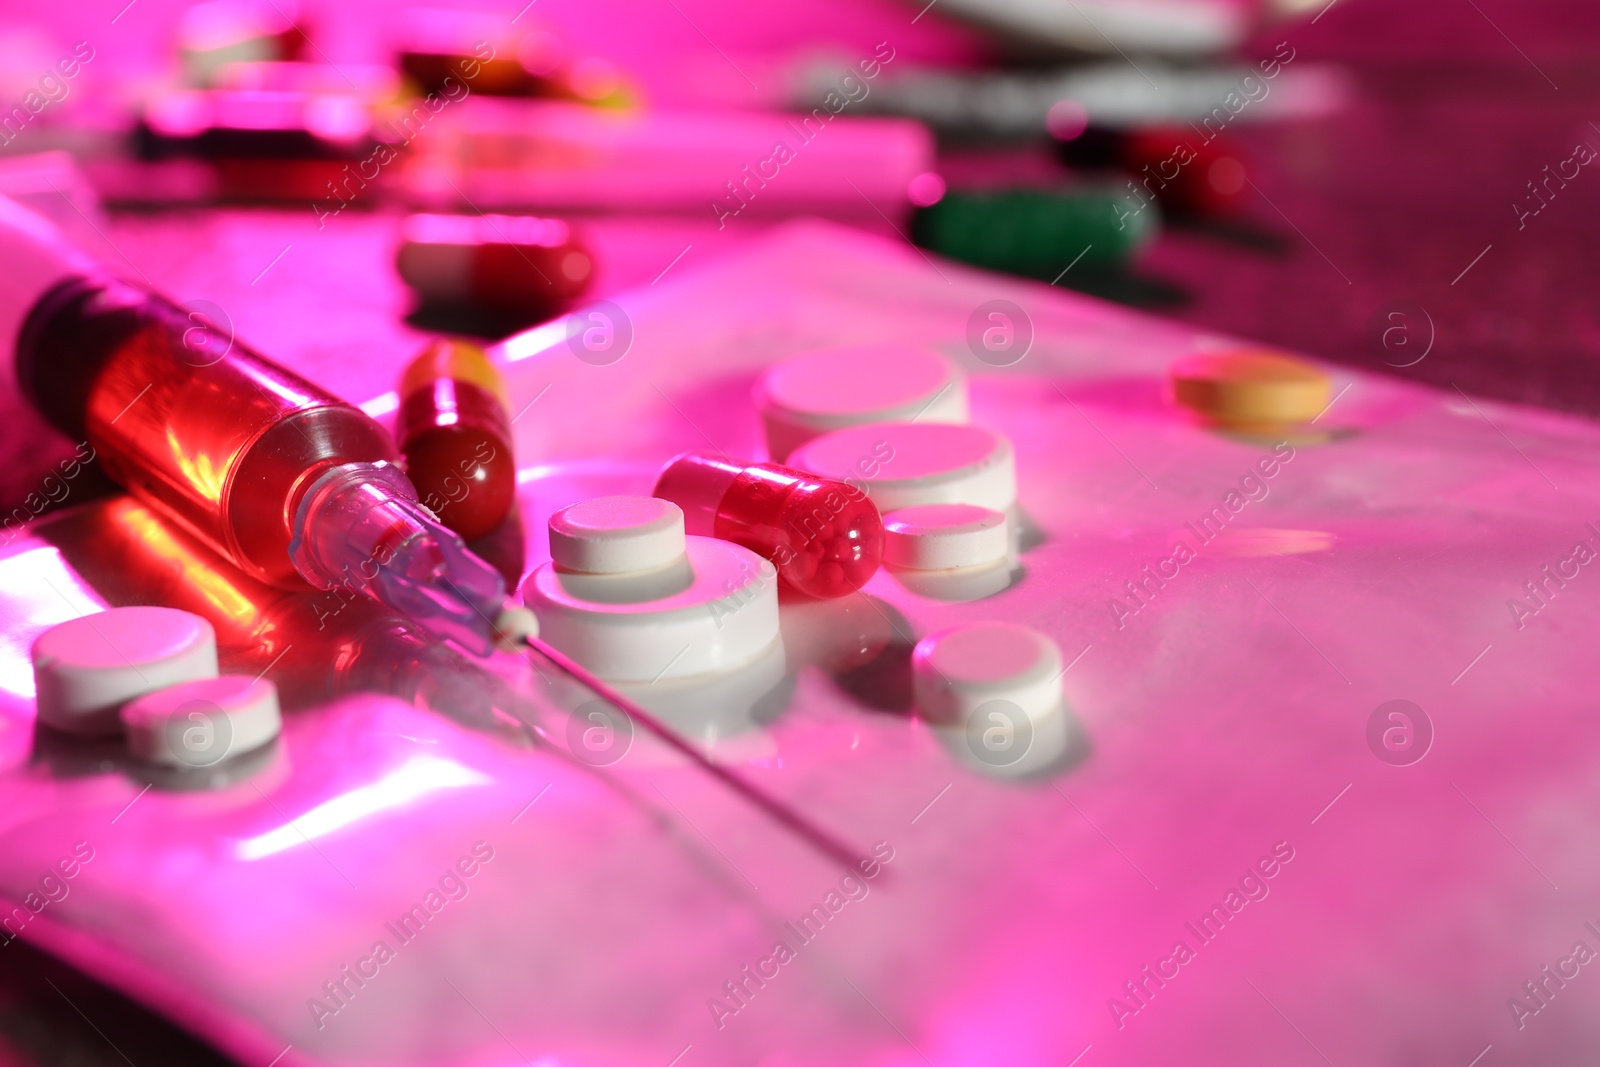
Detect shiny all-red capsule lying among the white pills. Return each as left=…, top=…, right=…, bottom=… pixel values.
left=654, top=453, right=883, bottom=600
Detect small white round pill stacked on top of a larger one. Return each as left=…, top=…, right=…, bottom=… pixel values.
left=550, top=496, right=683, bottom=574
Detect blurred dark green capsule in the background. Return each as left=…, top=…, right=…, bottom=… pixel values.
left=912, top=189, right=1160, bottom=282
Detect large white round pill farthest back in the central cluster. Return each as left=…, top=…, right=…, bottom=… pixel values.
left=755, top=344, right=966, bottom=462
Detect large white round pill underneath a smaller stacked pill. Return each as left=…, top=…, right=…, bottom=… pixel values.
left=522, top=536, right=778, bottom=681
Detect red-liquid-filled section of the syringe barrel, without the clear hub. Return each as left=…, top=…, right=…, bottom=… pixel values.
left=16, top=271, right=398, bottom=585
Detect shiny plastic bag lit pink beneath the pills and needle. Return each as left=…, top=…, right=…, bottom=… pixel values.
left=0, top=226, right=1600, bottom=1067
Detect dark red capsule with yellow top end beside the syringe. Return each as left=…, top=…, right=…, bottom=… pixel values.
left=397, top=341, right=517, bottom=541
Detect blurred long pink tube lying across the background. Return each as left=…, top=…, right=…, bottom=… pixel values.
left=403, top=103, right=934, bottom=220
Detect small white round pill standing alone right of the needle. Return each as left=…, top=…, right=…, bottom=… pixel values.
left=910, top=622, right=1061, bottom=723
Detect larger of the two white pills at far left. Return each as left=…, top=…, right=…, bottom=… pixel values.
left=34, top=608, right=216, bottom=734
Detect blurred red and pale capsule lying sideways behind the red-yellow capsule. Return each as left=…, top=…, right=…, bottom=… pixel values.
left=395, top=214, right=594, bottom=323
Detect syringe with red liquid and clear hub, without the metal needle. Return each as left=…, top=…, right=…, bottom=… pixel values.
left=0, top=197, right=506, bottom=654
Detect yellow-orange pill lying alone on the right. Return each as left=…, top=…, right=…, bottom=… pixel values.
left=1170, top=349, right=1331, bottom=427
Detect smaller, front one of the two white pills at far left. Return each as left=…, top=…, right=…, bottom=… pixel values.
left=122, top=675, right=283, bottom=768
